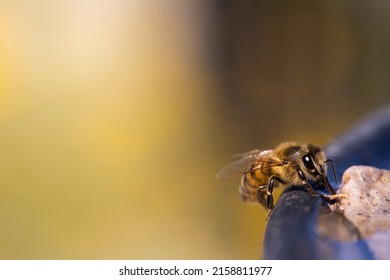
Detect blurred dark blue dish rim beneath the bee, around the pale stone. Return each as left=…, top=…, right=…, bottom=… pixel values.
left=263, top=104, right=390, bottom=259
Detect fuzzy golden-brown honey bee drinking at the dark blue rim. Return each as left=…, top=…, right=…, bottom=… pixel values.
left=217, top=142, right=339, bottom=218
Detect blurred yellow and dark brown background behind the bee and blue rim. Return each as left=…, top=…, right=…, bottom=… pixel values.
left=0, top=0, right=390, bottom=259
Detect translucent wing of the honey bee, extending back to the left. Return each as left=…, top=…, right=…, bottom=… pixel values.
left=217, top=150, right=272, bottom=179
